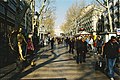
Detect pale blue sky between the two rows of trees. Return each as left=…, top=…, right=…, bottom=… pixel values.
left=36, top=0, right=93, bottom=28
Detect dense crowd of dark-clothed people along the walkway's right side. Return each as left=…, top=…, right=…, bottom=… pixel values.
left=62, top=36, right=120, bottom=80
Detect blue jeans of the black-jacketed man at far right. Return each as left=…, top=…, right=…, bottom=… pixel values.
left=108, top=58, right=116, bottom=78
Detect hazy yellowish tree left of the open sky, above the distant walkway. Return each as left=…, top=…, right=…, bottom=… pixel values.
left=40, top=0, right=56, bottom=35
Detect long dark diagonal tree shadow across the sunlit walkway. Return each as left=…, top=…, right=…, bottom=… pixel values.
left=10, top=51, right=69, bottom=80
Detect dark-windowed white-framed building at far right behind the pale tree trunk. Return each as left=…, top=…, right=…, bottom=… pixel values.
left=97, top=0, right=120, bottom=34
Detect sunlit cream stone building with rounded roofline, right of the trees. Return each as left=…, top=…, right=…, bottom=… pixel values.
left=67, top=4, right=103, bottom=35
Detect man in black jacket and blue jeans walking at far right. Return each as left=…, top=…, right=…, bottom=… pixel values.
left=103, top=36, right=120, bottom=80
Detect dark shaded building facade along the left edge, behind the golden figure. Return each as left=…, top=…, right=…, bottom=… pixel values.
left=0, top=0, right=35, bottom=68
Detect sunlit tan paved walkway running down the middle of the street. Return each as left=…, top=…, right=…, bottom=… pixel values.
left=11, top=46, right=120, bottom=80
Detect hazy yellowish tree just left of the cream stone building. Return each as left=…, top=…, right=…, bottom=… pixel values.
left=61, top=0, right=85, bottom=32
